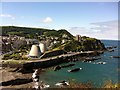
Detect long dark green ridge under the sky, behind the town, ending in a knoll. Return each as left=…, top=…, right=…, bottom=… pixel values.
left=2, top=26, right=73, bottom=39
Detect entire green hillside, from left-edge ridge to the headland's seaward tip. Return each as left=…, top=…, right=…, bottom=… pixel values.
left=2, top=26, right=105, bottom=52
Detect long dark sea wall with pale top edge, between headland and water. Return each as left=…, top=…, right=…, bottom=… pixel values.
left=23, top=51, right=102, bottom=69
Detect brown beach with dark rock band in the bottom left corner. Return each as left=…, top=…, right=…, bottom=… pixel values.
left=0, top=67, right=34, bottom=89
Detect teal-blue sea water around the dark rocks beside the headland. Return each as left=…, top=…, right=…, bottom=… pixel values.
left=40, top=40, right=120, bottom=87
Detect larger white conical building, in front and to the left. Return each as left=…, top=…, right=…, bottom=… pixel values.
left=29, top=45, right=41, bottom=58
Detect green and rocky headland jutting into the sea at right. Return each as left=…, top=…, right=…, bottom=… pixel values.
left=54, top=38, right=105, bottom=52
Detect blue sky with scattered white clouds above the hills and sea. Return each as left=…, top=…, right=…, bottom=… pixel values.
left=0, top=2, right=118, bottom=40
